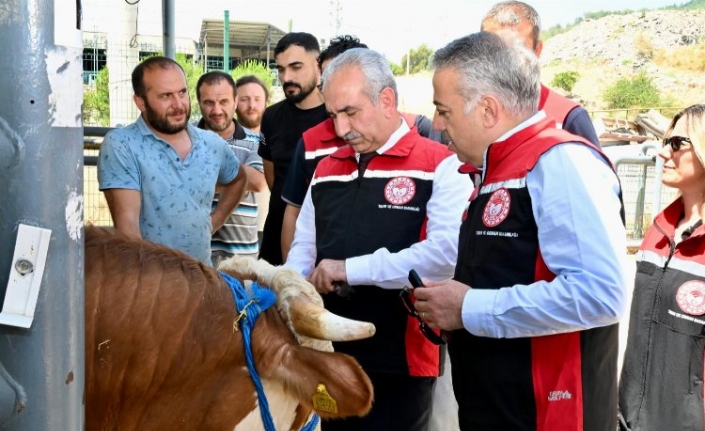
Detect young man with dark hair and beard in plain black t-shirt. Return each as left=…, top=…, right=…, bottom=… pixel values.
left=258, top=33, right=328, bottom=265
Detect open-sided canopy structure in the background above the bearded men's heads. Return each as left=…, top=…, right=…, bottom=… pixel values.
left=199, top=19, right=286, bottom=63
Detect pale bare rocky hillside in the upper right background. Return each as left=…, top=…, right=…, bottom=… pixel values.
left=541, top=9, right=705, bottom=109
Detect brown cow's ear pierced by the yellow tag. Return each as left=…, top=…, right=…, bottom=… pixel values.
left=263, top=344, right=373, bottom=418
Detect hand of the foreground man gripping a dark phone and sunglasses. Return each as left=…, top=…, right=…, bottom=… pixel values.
left=414, top=279, right=471, bottom=331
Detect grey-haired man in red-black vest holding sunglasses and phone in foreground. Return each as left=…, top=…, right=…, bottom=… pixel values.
left=415, top=32, right=627, bottom=431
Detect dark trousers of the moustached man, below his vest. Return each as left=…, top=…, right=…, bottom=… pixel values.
left=321, top=373, right=436, bottom=431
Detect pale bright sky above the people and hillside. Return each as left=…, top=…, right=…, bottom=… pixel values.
left=84, top=0, right=687, bottom=63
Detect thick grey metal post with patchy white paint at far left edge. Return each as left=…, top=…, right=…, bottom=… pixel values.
left=0, top=0, right=85, bottom=431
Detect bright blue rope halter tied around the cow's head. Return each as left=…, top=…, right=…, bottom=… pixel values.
left=220, top=272, right=318, bottom=431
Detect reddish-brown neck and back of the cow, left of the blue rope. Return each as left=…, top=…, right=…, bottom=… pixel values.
left=85, top=227, right=255, bottom=430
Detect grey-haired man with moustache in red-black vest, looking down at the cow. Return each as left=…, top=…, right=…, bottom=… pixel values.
left=286, top=48, right=472, bottom=431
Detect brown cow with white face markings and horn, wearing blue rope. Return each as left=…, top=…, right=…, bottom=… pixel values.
left=85, top=226, right=374, bottom=431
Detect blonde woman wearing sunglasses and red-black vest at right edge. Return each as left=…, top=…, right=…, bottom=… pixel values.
left=619, top=105, right=705, bottom=431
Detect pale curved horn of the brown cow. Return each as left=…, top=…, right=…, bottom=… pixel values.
left=289, top=298, right=375, bottom=341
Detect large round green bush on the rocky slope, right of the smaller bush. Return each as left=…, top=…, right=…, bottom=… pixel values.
left=602, top=72, right=661, bottom=109
